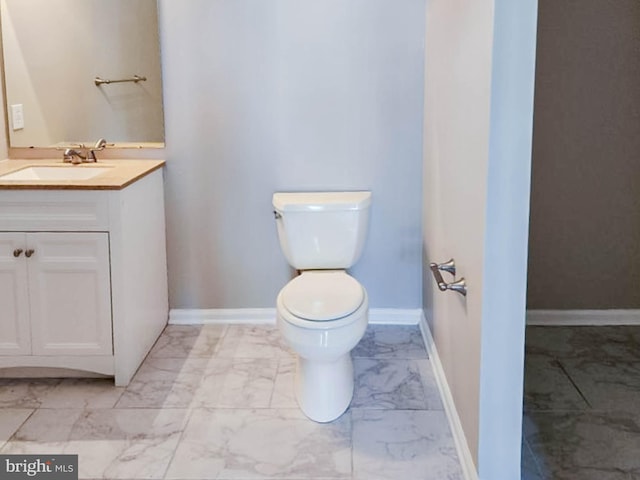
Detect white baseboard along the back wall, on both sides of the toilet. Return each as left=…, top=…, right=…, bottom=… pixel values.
left=169, top=308, right=422, bottom=325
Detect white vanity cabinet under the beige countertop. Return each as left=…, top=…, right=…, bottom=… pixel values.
left=0, top=169, right=168, bottom=385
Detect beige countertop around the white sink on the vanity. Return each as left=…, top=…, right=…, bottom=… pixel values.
left=0, top=159, right=164, bottom=190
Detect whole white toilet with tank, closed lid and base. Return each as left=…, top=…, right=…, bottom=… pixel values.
left=273, top=192, right=371, bottom=423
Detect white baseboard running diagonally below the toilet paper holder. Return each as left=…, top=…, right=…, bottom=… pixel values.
left=419, top=312, right=478, bottom=480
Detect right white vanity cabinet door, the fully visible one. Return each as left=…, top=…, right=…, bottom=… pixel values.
left=26, top=233, right=113, bottom=355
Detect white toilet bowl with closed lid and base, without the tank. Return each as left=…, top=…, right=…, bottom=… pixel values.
left=277, top=270, right=369, bottom=423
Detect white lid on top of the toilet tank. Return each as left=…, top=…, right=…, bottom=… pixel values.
left=272, top=191, right=371, bottom=212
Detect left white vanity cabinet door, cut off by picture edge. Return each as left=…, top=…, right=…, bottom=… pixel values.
left=0, top=233, right=31, bottom=355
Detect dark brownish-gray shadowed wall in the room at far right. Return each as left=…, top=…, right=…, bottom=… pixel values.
left=528, top=0, right=640, bottom=309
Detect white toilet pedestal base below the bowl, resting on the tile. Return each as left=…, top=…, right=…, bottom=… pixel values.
left=295, top=353, right=354, bottom=423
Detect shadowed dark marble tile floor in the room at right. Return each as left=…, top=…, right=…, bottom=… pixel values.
left=522, top=326, right=640, bottom=480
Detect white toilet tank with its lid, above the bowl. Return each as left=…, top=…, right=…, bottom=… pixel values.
left=273, top=192, right=371, bottom=270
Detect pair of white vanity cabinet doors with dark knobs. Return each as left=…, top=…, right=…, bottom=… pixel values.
left=0, top=232, right=113, bottom=355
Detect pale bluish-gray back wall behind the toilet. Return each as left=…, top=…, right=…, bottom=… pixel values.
left=160, top=0, right=425, bottom=308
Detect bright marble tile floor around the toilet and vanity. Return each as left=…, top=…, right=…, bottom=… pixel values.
left=0, top=325, right=463, bottom=480
